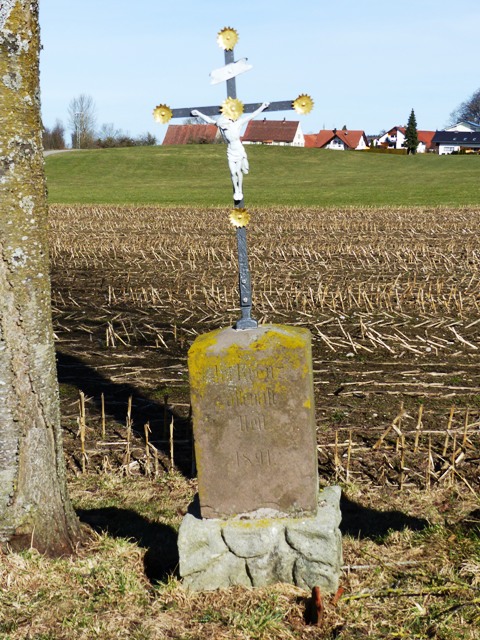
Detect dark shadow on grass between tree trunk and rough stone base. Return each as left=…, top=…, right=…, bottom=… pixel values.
left=77, top=507, right=178, bottom=582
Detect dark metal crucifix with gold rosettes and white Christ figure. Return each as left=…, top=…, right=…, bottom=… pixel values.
left=153, top=27, right=313, bottom=330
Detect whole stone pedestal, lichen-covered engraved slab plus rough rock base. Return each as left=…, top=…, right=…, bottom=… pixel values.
left=178, top=325, right=342, bottom=591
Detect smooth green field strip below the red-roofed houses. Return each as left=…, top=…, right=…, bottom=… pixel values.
left=46, top=145, right=480, bottom=207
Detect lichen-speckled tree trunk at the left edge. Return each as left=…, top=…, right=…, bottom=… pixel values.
left=0, top=0, right=80, bottom=555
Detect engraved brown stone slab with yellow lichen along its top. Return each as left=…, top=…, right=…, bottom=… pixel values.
left=188, top=325, right=318, bottom=518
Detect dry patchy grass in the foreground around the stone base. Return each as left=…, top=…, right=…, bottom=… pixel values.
left=0, top=473, right=480, bottom=640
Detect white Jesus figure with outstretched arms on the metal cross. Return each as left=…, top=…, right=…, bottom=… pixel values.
left=191, top=102, right=270, bottom=202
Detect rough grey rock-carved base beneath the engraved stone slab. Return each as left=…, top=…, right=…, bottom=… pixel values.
left=178, top=487, right=342, bottom=593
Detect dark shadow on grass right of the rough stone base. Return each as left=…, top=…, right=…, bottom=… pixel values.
left=340, top=493, right=429, bottom=540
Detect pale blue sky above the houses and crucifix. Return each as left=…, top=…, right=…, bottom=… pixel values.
left=40, top=0, right=480, bottom=140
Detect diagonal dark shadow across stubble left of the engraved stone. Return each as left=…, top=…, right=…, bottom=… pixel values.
left=57, top=351, right=192, bottom=477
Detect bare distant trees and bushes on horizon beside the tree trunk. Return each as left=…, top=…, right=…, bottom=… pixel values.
left=42, top=94, right=157, bottom=150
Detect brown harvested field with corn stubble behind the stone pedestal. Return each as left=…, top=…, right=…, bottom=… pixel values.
left=51, top=206, right=480, bottom=491
